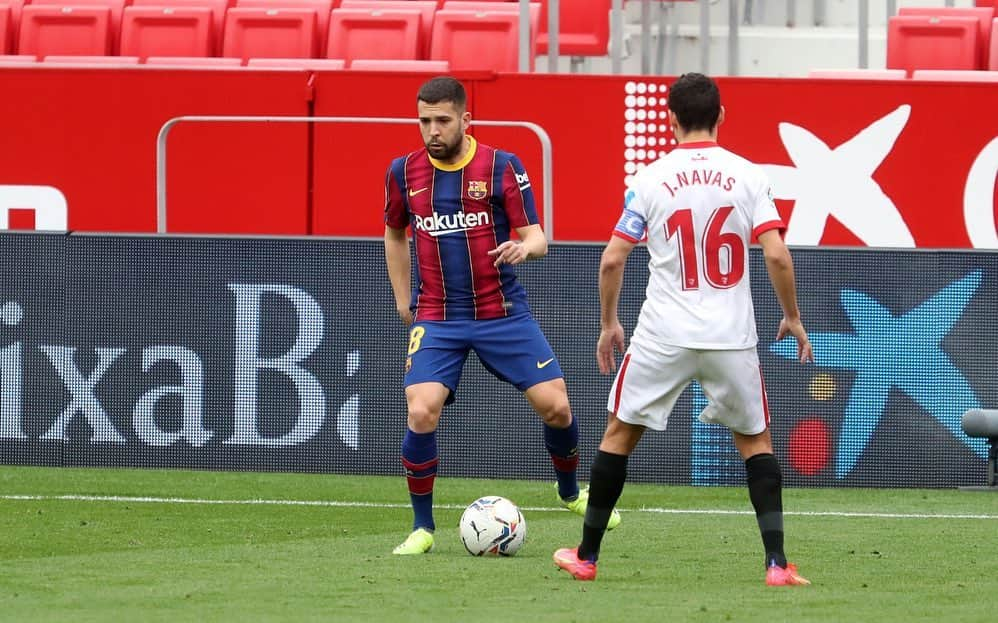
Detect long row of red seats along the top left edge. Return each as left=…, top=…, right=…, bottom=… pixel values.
left=0, top=0, right=610, bottom=71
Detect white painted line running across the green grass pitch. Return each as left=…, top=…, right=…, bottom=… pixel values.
left=0, top=495, right=998, bottom=519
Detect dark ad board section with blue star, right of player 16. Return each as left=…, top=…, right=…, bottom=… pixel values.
left=766, top=253, right=998, bottom=486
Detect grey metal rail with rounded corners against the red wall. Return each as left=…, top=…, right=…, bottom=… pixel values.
left=156, top=115, right=554, bottom=240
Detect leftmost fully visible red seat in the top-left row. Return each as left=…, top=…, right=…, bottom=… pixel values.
left=17, top=4, right=112, bottom=58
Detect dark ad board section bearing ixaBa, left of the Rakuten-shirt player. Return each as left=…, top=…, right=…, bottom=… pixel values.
left=0, top=233, right=404, bottom=471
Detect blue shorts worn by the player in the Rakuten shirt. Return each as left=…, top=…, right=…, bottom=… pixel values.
left=405, top=313, right=562, bottom=404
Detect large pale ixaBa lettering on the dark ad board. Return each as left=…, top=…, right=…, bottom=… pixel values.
left=0, top=283, right=361, bottom=450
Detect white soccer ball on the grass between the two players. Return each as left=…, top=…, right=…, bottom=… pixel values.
left=458, top=495, right=527, bottom=556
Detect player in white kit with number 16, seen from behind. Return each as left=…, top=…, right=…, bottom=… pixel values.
left=554, top=73, right=813, bottom=586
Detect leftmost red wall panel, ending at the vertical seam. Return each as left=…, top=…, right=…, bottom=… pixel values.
left=0, top=68, right=308, bottom=233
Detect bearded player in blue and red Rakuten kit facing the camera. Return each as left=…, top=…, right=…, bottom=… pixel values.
left=385, top=77, right=620, bottom=554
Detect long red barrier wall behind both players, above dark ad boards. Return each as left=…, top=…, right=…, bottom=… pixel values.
left=0, top=67, right=998, bottom=248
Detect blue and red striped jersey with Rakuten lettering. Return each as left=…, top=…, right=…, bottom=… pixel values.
left=385, top=136, right=539, bottom=320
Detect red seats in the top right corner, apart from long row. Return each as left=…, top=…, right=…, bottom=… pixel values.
left=887, top=6, right=998, bottom=75
